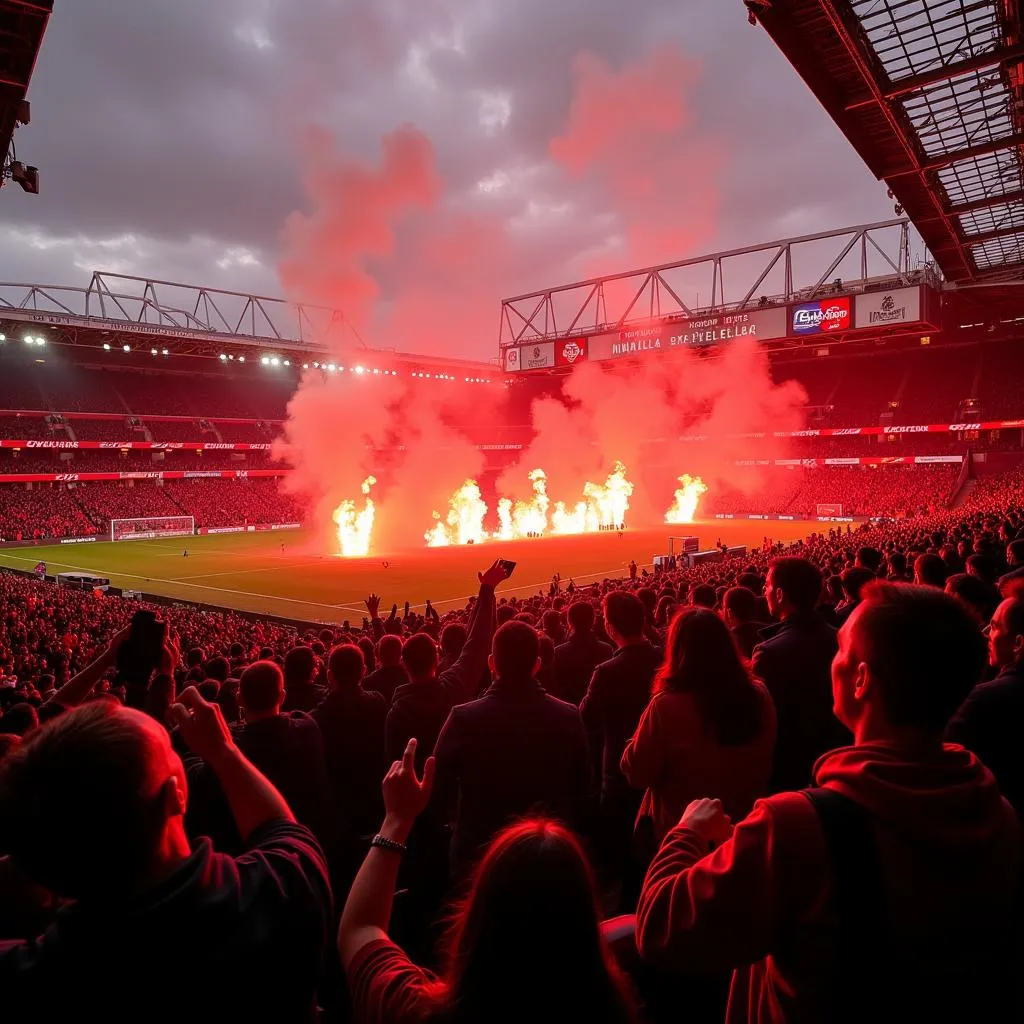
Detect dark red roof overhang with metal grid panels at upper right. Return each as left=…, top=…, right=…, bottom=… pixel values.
left=744, top=0, right=1024, bottom=284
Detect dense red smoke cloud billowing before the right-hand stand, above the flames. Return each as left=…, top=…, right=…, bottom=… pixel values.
left=498, top=340, right=807, bottom=525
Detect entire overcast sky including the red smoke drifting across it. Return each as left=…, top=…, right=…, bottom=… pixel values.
left=0, top=0, right=892, bottom=356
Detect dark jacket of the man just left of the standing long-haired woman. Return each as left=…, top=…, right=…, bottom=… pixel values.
left=580, top=641, right=665, bottom=806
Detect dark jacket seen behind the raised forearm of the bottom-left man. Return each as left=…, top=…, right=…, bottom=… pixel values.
left=184, top=711, right=329, bottom=855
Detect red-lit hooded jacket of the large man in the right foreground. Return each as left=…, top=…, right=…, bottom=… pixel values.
left=637, top=743, right=1022, bottom=1024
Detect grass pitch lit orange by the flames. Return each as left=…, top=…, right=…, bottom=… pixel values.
left=0, top=521, right=811, bottom=622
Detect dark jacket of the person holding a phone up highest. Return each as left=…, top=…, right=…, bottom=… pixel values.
left=387, top=587, right=495, bottom=771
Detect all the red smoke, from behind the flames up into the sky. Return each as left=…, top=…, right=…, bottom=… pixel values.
left=278, top=48, right=805, bottom=551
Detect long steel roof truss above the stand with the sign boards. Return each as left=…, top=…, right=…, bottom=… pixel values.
left=499, top=218, right=913, bottom=347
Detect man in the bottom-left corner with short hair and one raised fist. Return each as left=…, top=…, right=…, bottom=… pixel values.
left=0, top=688, right=332, bottom=1024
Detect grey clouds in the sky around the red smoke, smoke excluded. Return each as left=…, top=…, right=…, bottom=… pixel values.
left=0, top=0, right=891, bottom=339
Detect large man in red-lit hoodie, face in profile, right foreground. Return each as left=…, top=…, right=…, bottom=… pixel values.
left=637, top=583, right=1022, bottom=1024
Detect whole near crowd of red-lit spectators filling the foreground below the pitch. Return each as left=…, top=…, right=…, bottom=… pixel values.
left=0, top=471, right=1024, bottom=1022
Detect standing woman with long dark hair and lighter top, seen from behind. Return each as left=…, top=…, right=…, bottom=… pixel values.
left=622, top=606, right=775, bottom=842
